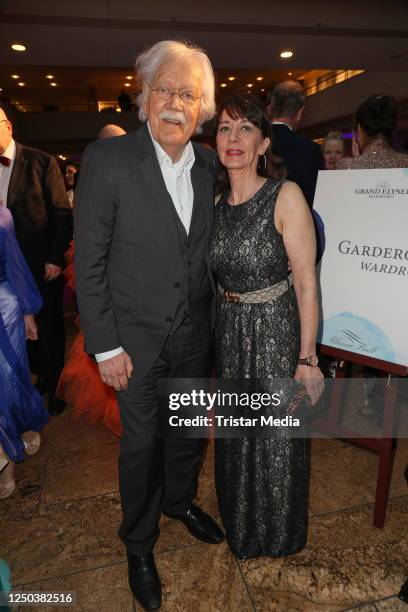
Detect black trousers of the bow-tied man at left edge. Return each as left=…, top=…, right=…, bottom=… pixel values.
left=27, top=277, right=65, bottom=391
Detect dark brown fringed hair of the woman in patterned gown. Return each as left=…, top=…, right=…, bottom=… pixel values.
left=216, top=93, right=286, bottom=194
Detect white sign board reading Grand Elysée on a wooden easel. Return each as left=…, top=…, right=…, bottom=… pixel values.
left=313, top=169, right=408, bottom=366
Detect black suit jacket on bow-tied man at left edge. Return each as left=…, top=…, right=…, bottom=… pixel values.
left=7, top=143, right=72, bottom=285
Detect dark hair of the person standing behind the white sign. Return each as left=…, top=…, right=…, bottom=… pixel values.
left=356, top=96, right=397, bottom=138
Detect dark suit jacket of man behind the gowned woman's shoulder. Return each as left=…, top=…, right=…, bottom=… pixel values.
left=272, top=124, right=324, bottom=208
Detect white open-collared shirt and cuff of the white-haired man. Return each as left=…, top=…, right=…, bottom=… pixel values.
left=95, top=123, right=195, bottom=362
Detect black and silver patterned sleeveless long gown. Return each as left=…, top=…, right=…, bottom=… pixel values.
left=210, top=179, right=309, bottom=558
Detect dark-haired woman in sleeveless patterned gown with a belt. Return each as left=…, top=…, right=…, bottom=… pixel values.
left=210, top=95, right=323, bottom=558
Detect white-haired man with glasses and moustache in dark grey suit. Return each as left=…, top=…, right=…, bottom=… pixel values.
left=75, top=41, right=224, bottom=610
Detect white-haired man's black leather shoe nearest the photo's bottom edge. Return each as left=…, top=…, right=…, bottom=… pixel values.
left=128, top=553, right=161, bottom=611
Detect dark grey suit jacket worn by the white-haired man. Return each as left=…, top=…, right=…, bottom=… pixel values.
left=74, top=125, right=213, bottom=374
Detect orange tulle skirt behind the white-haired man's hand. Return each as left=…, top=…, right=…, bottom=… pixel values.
left=57, top=332, right=122, bottom=436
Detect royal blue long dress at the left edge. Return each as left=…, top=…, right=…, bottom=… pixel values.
left=0, top=205, right=48, bottom=461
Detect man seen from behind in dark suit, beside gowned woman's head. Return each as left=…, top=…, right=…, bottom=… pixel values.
left=268, top=81, right=324, bottom=208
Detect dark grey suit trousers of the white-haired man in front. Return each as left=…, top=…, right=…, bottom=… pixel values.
left=117, top=318, right=211, bottom=555
